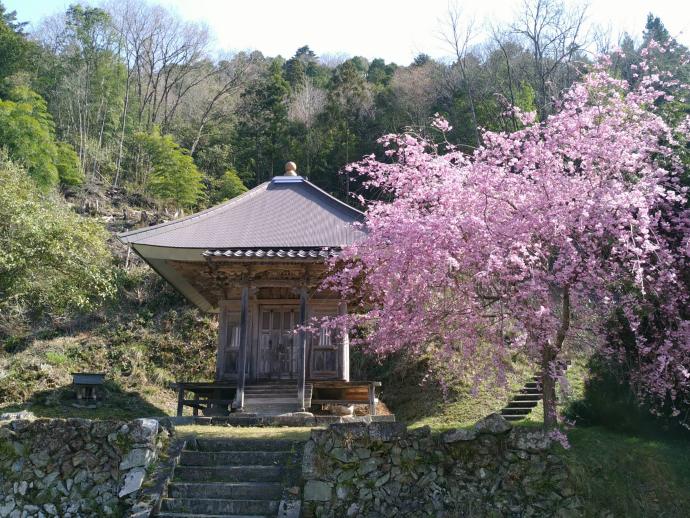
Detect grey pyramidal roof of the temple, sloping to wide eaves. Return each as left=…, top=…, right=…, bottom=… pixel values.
left=118, top=176, right=364, bottom=251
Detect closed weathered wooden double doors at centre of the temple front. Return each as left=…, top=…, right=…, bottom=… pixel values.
left=257, top=305, right=292, bottom=379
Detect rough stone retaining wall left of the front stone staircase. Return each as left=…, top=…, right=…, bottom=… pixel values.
left=0, top=415, right=168, bottom=518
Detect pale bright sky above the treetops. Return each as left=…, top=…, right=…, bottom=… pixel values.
left=5, top=0, right=690, bottom=65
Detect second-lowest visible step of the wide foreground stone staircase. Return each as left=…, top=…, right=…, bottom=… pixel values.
left=168, top=481, right=283, bottom=500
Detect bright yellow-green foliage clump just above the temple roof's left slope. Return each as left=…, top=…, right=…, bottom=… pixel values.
left=134, top=127, right=203, bottom=207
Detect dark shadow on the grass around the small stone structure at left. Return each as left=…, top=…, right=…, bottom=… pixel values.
left=0, top=381, right=166, bottom=419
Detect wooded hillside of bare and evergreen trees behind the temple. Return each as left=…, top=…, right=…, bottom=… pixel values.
left=0, top=0, right=669, bottom=210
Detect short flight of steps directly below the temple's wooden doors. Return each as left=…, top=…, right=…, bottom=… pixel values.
left=244, top=381, right=312, bottom=417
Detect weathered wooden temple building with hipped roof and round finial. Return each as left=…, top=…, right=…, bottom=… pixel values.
left=118, top=162, right=378, bottom=415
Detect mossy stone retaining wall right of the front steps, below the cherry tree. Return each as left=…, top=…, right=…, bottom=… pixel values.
left=302, top=414, right=581, bottom=518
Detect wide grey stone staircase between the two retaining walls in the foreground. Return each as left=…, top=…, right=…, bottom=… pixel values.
left=157, top=439, right=302, bottom=518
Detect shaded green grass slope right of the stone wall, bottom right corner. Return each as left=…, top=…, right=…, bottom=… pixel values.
left=562, top=427, right=690, bottom=518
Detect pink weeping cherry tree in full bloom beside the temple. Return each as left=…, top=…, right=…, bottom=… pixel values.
left=325, top=50, right=690, bottom=427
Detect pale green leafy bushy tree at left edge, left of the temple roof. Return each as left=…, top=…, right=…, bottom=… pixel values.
left=0, top=154, right=114, bottom=334
